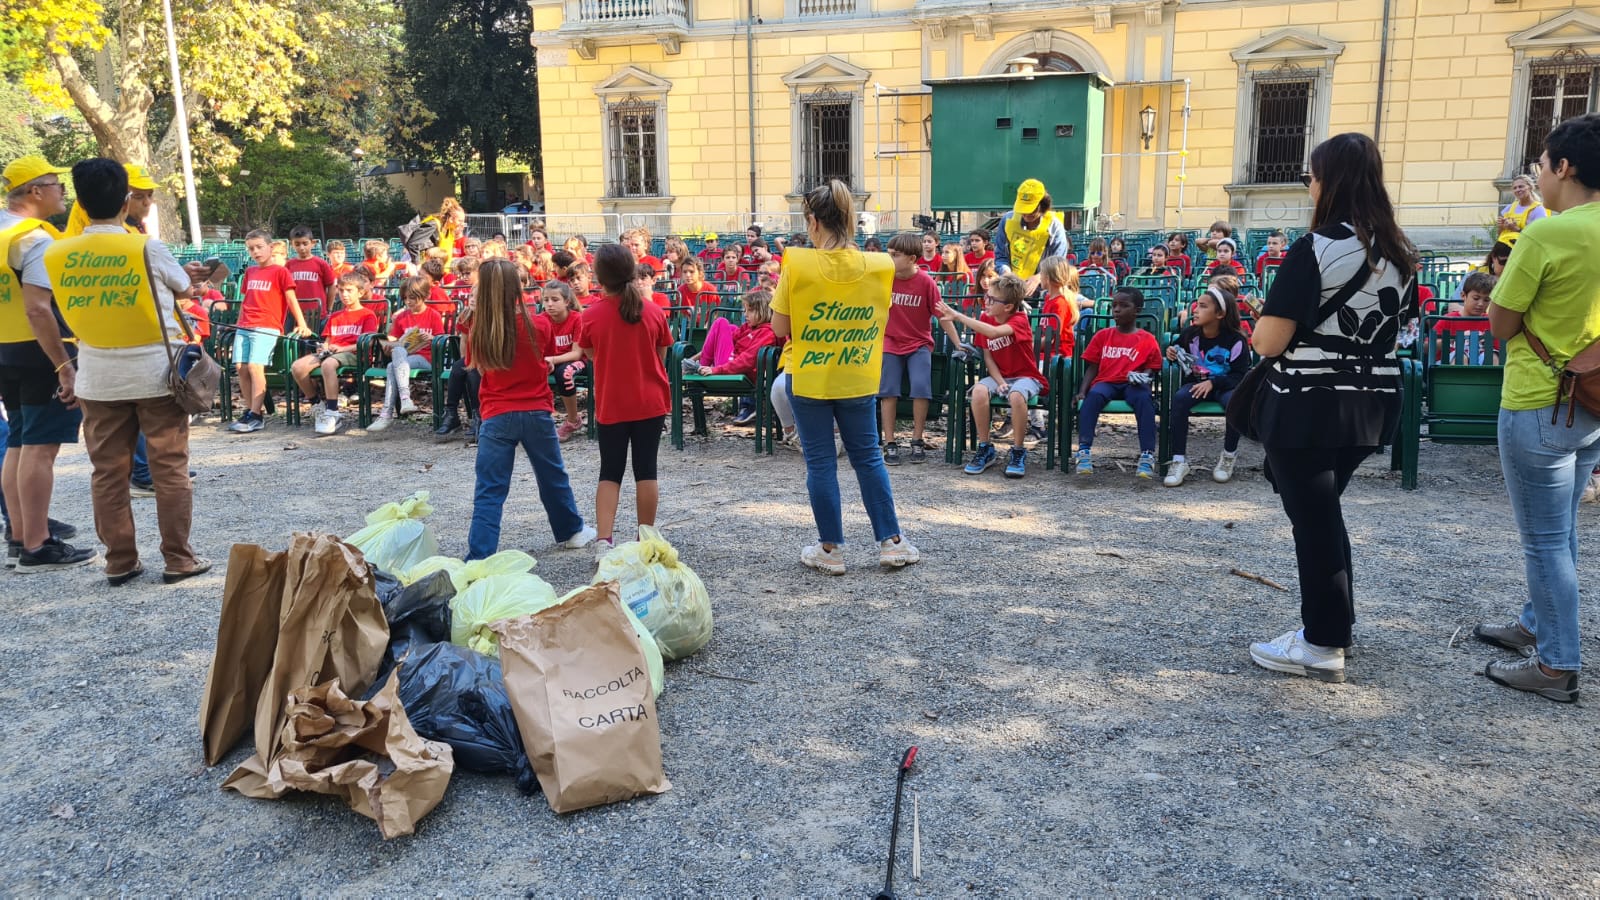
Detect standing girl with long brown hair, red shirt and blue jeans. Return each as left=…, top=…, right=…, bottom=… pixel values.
left=466, top=256, right=598, bottom=560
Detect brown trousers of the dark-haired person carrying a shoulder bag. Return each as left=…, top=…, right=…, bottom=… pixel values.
left=82, top=397, right=197, bottom=575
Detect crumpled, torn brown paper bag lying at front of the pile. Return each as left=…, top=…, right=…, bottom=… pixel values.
left=266, top=669, right=454, bottom=841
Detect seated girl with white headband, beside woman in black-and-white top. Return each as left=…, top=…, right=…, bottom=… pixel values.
left=1162, top=285, right=1250, bottom=487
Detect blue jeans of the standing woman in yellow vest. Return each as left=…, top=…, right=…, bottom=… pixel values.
left=789, top=376, right=901, bottom=546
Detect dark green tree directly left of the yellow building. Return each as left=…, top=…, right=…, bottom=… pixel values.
left=397, top=0, right=539, bottom=211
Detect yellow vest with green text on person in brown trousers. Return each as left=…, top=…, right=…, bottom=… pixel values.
left=45, top=234, right=163, bottom=349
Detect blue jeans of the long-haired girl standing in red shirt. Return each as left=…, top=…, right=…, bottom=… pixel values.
left=467, top=410, right=584, bottom=560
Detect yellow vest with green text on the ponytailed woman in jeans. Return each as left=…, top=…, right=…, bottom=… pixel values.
left=779, top=247, right=894, bottom=400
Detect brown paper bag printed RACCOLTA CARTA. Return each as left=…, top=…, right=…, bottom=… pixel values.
left=491, top=581, right=672, bottom=812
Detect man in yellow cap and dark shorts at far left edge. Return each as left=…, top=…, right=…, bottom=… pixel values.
left=0, top=157, right=98, bottom=573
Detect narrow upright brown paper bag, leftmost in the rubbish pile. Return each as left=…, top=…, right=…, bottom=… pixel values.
left=200, top=544, right=285, bottom=765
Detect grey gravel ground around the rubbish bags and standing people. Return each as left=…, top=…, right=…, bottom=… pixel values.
left=0, top=406, right=1600, bottom=897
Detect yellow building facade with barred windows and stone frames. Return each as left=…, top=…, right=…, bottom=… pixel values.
left=531, top=0, right=1600, bottom=239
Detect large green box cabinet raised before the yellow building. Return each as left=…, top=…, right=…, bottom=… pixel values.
left=926, top=72, right=1107, bottom=211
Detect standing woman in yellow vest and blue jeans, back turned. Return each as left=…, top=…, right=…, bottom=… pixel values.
left=773, top=179, right=920, bottom=575
